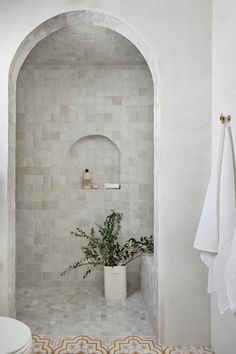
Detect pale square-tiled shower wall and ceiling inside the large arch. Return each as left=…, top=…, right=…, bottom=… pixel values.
left=16, top=13, right=155, bottom=335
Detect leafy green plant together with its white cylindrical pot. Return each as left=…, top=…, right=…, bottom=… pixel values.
left=60, top=210, right=154, bottom=300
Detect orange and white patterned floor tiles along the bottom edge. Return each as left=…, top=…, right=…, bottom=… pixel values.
left=32, top=335, right=214, bottom=354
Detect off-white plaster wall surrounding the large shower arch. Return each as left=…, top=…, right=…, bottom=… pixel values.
left=0, top=0, right=211, bottom=345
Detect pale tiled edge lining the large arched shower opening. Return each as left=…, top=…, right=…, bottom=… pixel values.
left=8, top=10, right=159, bottom=332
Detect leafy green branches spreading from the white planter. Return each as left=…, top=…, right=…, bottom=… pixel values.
left=60, top=210, right=154, bottom=278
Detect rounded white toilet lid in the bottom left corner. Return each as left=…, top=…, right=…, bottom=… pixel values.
left=0, top=316, right=31, bottom=354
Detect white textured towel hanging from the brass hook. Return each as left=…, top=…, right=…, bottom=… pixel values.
left=194, top=122, right=236, bottom=313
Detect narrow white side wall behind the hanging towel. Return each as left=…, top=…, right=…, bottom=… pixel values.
left=211, top=0, right=236, bottom=354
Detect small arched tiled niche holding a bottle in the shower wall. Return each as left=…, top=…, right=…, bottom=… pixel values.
left=67, top=134, right=120, bottom=191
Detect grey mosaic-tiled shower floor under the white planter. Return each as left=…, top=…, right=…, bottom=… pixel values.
left=16, top=286, right=154, bottom=337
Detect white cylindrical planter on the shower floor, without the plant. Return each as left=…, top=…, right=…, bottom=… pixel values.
left=104, top=266, right=127, bottom=300
